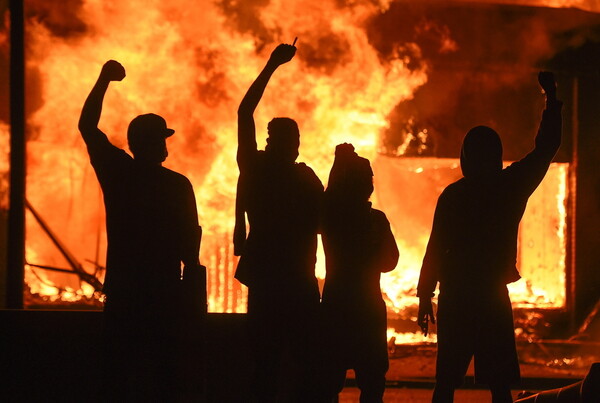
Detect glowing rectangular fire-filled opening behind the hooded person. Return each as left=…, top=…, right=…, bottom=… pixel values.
left=374, top=157, right=568, bottom=313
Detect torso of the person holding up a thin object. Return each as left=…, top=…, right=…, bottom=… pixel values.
left=236, top=151, right=323, bottom=292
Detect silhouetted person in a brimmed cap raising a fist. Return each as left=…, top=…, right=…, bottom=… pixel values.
left=79, top=60, right=199, bottom=401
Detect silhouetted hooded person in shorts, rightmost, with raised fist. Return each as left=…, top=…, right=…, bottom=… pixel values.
left=417, top=72, right=562, bottom=403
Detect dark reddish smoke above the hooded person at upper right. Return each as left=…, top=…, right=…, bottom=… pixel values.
left=368, top=2, right=600, bottom=159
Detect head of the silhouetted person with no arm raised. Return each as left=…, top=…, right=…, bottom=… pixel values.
left=326, top=143, right=373, bottom=203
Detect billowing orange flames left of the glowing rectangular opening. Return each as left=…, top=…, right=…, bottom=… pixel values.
left=18, top=1, right=426, bottom=312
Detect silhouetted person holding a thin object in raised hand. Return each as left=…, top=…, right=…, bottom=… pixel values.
left=234, top=44, right=323, bottom=402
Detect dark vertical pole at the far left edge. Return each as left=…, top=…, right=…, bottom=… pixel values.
left=6, top=0, right=25, bottom=309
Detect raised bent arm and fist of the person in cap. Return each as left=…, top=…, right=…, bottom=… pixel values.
left=79, top=60, right=125, bottom=146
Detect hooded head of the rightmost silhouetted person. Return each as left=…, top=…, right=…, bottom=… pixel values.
left=460, top=126, right=502, bottom=178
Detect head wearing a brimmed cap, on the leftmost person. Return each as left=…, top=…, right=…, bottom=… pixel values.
left=127, top=113, right=175, bottom=164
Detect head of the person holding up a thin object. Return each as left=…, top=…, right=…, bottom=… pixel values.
left=265, top=118, right=300, bottom=163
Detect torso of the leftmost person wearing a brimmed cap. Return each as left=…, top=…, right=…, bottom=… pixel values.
left=90, top=148, right=196, bottom=310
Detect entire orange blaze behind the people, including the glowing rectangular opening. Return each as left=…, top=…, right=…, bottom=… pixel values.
left=0, top=0, right=587, bottom=340
